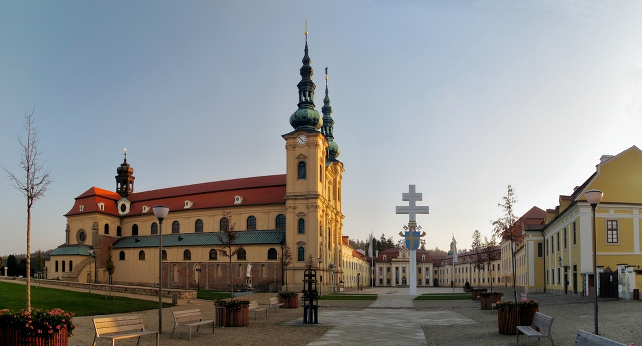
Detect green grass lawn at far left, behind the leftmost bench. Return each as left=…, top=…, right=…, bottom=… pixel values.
left=0, top=282, right=172, bottom=316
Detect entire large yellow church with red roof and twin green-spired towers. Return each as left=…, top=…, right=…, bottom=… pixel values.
left=46, top=32, right=344, bottom=292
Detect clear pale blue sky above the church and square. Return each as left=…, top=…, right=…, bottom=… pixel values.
left=0, top=0, right=642, bottom=255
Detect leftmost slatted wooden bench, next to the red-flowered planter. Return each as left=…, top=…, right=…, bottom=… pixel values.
left=93, top=315, right=159, bottom=346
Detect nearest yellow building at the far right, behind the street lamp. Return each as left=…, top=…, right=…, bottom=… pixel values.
left=538, top=146, right=642, bottom=298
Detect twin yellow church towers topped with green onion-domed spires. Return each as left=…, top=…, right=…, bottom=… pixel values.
left=283, top=28, right=343, bottom=291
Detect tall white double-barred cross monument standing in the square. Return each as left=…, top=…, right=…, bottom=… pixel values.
left=397, top=185, right=428, bottom=295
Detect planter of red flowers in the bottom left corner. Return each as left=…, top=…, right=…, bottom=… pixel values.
left=0, top=309, right=76, bottom=346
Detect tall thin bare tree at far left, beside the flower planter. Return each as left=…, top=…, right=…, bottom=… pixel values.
left=2, top=109, right=53, bottom=310
